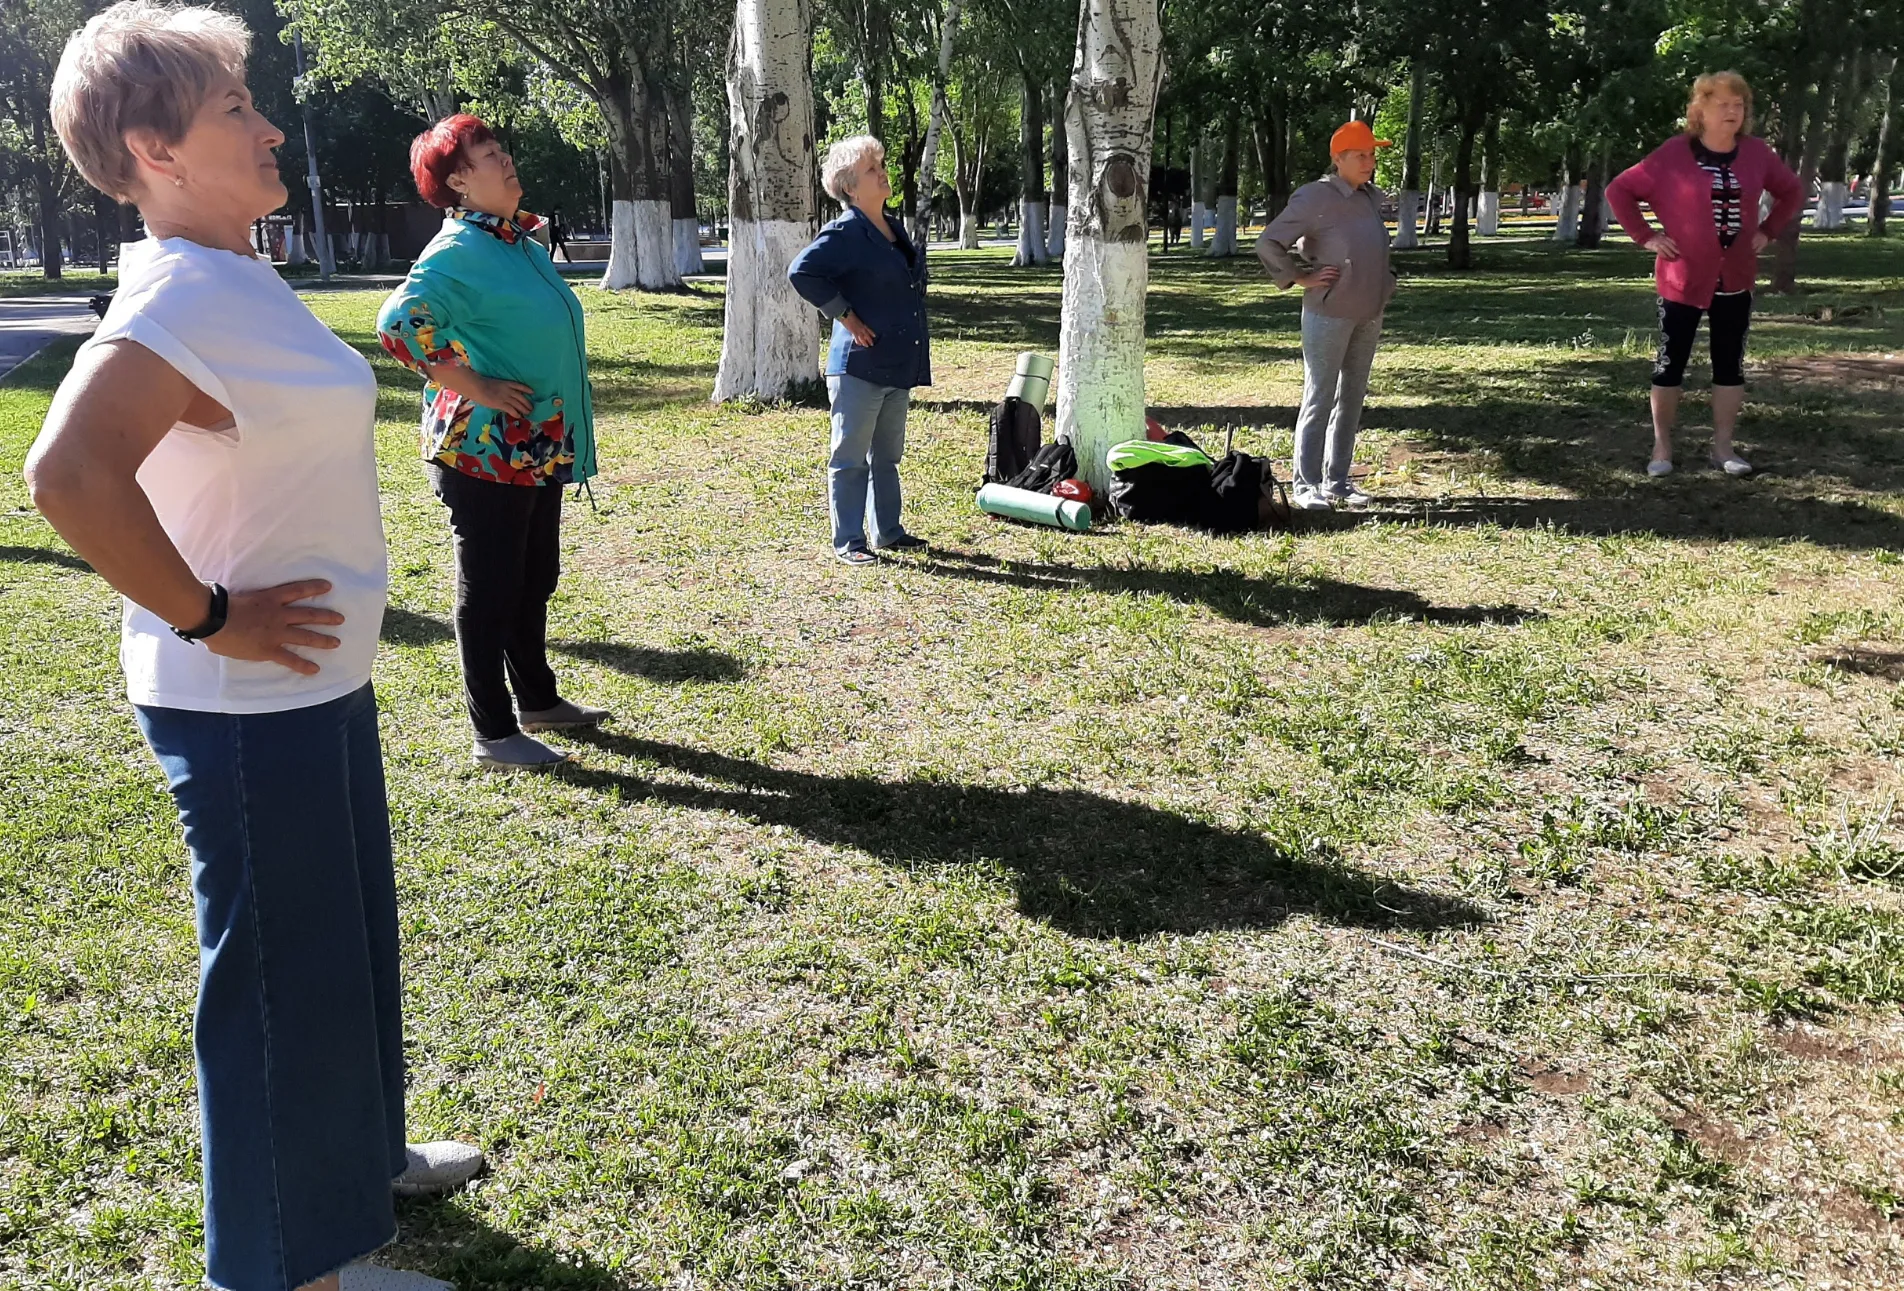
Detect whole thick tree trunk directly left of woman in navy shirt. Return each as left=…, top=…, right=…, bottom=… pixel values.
left=714, top=0, right=819, bottom=402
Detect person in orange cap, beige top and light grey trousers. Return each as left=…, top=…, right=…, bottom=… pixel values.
left=1257, top=122, right=1396, bottom=510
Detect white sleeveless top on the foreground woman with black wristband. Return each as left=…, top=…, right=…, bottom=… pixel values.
left=88, top=238, right=388, bottom=712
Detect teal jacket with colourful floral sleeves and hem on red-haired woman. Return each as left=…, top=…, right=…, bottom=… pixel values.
left=377, top=209, right=596, bottom=486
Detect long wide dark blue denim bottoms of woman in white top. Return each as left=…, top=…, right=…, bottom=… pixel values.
left=137, top=685, right=406, bottom=1291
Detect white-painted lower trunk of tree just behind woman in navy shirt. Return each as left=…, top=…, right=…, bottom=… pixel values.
left=714, top=219, right=819, bottom=404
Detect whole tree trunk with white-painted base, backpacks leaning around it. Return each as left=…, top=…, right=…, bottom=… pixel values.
left=1057, top=0, right=1163, bottom=495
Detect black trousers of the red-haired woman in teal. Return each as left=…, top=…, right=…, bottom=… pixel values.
left=428, top=461, right=562, bottom=739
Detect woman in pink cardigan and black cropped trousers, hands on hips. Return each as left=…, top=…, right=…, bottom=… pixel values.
left=1607, top=72, right=1803, bottom=476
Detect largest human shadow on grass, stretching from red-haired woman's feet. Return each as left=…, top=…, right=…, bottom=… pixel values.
left=558, top=731, right=1485, bottom=937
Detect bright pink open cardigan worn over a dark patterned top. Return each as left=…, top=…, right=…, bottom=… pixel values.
left=1607, top=135, right=1805, bottom=308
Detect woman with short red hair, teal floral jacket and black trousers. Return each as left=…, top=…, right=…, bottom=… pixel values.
left=377, top=114, right=607, bottom=767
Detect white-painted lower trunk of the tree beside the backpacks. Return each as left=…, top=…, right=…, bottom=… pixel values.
left=1057, top=236, right=1150, bottom=495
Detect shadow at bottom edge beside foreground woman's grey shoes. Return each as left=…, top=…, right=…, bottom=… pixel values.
left=387, top=1196, right=628, bottom=1291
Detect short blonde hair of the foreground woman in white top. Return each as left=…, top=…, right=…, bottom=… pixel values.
left=53, top=0, right=251, bottom=202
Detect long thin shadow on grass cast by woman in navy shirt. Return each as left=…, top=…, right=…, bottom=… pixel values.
left=918, top=548, right=1546, bottom=628
